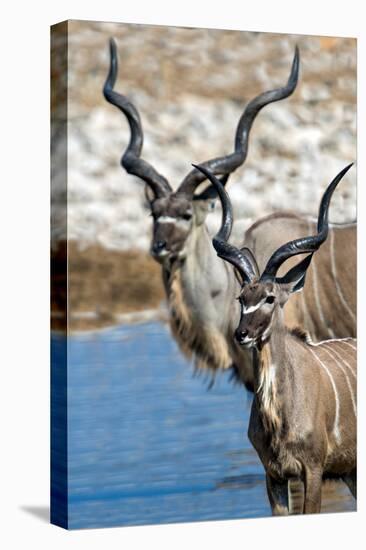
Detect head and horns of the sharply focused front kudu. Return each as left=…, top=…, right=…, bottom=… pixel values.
left=196, top=164, right=352, bottom=349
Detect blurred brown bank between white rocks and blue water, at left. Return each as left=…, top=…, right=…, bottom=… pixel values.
left=51, top=242, right=164, bottom=330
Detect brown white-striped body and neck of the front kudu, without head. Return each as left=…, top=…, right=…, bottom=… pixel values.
left=249, top=312, right=356, bottom=514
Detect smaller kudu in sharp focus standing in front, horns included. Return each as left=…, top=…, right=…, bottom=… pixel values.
left=197, top=165, right=356, bottom=514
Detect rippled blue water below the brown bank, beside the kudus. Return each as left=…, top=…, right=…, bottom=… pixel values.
left=53, top=323, right=353, bottom=529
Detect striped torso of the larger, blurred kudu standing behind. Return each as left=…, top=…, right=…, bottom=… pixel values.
left=245, top=212, right=357, bottom=340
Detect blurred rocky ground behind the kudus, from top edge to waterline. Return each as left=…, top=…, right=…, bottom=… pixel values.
left=52, top=21, right=356, bottom=328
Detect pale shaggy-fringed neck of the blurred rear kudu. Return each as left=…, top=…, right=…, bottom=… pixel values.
left=163, top=218, right=239, bottom=371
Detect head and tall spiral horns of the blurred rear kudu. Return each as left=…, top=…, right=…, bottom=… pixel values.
left=103, top=39, right=299, bottom=264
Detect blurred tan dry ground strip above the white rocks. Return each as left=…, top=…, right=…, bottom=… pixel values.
left=64, top=21, right=355, bottom=115
